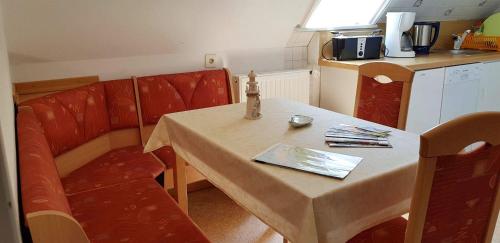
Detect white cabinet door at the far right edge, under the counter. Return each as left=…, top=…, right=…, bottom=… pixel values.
left=478, top=61, right=500, bottom=111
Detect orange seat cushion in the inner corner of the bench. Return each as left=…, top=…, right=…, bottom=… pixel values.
left=61, top=145, right=165, bottom=195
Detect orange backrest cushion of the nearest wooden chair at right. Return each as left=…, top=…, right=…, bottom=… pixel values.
left=422, top=144, right=500, bottom=242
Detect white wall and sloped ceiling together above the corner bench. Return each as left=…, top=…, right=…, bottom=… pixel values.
left=1, top=0, right=313, bottom=82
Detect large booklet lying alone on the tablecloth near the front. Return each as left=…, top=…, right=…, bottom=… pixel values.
left=252, top=143, right=363, bottom=179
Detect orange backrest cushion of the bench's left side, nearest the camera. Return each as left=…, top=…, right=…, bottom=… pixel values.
left=17, top=109, right=71, bottom=215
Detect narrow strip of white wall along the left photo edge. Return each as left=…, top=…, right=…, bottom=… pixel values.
left=0, top=0, right=20, bottom=242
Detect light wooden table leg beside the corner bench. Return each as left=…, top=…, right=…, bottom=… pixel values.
left=174, top=155, right=188, bottom=214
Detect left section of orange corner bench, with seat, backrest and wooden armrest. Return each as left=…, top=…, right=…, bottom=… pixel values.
left=17, top=109, right=208, bottom=243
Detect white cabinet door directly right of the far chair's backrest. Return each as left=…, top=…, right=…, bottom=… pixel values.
left=406, top=68, right=445, bottom=134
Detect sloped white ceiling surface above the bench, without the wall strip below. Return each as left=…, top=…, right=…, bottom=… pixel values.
left=2, top=0, right=313, bottom=62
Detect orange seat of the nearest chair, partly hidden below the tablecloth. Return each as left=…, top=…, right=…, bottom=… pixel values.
left=347, top=217, right=407, bottom=243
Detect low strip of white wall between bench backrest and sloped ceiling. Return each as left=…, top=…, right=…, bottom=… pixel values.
left=11, top=48, right=285, bottom=82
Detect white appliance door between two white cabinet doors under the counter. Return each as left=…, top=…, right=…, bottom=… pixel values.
left=440, top=64, right=482, bottom=123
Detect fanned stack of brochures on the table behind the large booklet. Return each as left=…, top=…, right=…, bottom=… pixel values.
left=325, top=124, right=392, bottom=148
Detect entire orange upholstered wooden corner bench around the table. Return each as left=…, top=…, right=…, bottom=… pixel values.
left=17, top=70, right=233, bottom=242
